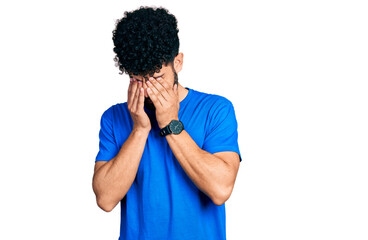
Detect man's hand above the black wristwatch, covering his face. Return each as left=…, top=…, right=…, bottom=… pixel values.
left=146, top=78, right=180, bottom=128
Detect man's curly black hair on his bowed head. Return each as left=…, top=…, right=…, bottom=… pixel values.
left=112, top=6, right=179, bottom=76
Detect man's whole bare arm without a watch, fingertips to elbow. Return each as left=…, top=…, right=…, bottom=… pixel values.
left=92, top=79, right=151, bottom=212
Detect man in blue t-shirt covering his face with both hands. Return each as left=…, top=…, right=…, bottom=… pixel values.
left=93, top=7, right=241, bottom=240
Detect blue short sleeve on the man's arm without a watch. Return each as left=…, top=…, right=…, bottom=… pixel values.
left=95, top=107, right=118, bottom=161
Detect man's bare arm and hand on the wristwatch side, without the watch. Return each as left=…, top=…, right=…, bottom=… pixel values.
left=147, top=78, right=240, bottom=205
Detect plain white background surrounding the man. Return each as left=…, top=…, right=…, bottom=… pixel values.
left=0, top=0, right=368, bottom=240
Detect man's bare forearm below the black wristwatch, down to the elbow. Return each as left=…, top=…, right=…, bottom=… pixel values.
left=166, top=130, right=234, bottom=205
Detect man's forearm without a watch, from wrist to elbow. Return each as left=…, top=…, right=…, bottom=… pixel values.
left=93, top=130, right=149, bottom=211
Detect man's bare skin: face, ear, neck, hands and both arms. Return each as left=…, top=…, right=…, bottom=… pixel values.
left=93, top=53, right=239, bottom=212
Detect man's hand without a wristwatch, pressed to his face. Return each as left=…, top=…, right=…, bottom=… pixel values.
left=127, top=78, right=151, bottom=132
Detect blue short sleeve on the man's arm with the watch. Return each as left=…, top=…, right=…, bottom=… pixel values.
left=202, top=98, right=242, bottom=161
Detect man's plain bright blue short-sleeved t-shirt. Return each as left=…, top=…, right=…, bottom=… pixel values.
left=96, top=88, right=241, bottom=240
